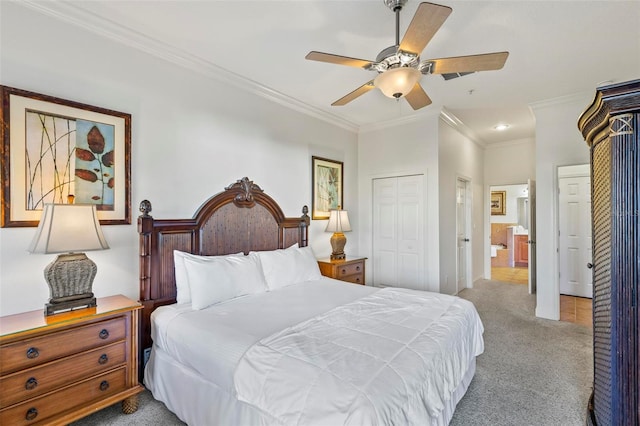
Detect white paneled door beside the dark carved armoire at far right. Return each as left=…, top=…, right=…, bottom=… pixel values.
left=558, top=169, right=593, bottom=298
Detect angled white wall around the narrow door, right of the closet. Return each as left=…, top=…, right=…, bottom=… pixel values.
left=438, top=120, right=485, bottom=294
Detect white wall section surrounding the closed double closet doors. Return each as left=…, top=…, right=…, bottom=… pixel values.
left=358, top=111, right=440, bottom=292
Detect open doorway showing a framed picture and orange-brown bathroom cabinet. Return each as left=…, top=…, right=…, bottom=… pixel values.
left=489, top=183, right=532, bottom=288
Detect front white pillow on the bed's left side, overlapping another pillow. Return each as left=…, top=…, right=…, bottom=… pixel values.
left=184, top=255, right=267, bottom=310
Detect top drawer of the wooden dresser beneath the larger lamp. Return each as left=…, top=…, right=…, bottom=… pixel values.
left=0, top=317, right=126, bottom=375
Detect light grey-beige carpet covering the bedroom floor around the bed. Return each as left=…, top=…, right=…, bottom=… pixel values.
left=73, top=280, right=593, bottom=426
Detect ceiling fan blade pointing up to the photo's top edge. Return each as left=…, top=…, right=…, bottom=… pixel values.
left=400, top=2, right=453, bottom=55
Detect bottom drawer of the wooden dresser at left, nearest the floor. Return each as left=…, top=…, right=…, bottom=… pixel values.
left=0, top=367, right=126, bottom=425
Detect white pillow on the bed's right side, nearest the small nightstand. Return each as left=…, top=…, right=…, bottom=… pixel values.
left=252, top=245, right=322, bottom=290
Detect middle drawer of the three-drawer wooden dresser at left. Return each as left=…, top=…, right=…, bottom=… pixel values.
left=0, top=341, right=126, bottom=408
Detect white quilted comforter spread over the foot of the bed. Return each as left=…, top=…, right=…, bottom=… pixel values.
left=234, top=288, right=484, bottom=425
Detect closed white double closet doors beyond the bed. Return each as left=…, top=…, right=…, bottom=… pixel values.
left=372, top=175, right=425, bottom=290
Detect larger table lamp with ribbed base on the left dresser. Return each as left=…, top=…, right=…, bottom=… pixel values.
left=29, top=204, right=109, bottom=316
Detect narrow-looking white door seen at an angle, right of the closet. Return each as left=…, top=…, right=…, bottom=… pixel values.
left=456, top=178, right=471, bottom=294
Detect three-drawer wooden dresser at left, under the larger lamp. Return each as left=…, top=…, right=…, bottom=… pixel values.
left=0, top=296, right=144, bottom=425
